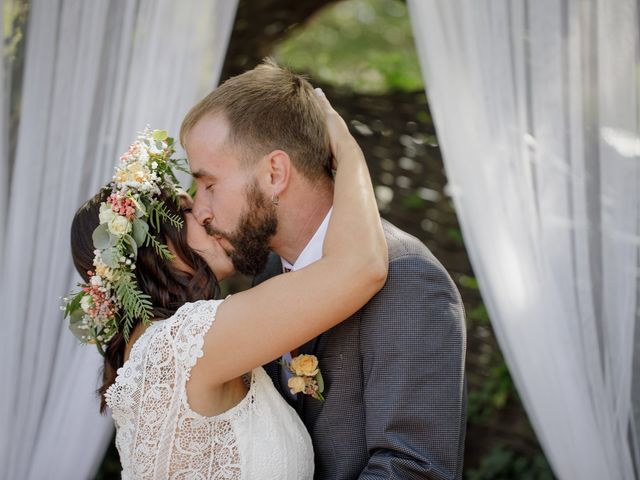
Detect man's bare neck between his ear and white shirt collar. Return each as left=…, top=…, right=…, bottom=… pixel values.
left=271, top=181, right=333, bottom=264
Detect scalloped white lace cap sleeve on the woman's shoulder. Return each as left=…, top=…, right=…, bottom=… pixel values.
left=175, top=300, right=223, bottom=379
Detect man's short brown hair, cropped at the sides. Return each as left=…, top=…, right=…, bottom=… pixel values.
left=180, top=59, right=332, bottom=181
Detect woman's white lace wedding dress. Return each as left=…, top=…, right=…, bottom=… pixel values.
left=106, top=300, right=313, bottom=480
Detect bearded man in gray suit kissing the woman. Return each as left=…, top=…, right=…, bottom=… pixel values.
left=180, top=62, right=466, bottom=480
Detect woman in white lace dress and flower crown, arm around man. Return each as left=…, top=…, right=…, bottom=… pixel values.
left=66, top=89, right=387, bottom=480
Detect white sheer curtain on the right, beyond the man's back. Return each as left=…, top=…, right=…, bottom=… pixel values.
left=409, top=0, right=640, bottom=480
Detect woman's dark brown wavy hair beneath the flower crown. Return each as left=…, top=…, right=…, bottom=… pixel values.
left=71, top=189, right=220, bottom=413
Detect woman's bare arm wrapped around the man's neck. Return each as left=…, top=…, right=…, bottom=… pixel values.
left=198, top=94, right=388, bottom=386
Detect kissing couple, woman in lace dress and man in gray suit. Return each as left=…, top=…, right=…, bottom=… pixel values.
left=66, top=62, right=466, bottom=480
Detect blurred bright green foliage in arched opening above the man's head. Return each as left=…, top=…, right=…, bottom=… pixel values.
left=275, top=0, right=423, bottom=94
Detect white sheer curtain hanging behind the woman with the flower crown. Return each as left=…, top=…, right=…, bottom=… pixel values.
left=0, top=0, right=236, bottom=479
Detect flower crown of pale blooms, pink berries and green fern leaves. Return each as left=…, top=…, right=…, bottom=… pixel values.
left=62, top=128, right=188, bottom=355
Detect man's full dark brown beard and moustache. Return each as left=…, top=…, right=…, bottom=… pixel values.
left=205, top=182, right=278, bottom=275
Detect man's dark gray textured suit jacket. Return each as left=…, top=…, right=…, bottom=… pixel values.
left=255, top=222, right=466, bottom=480
